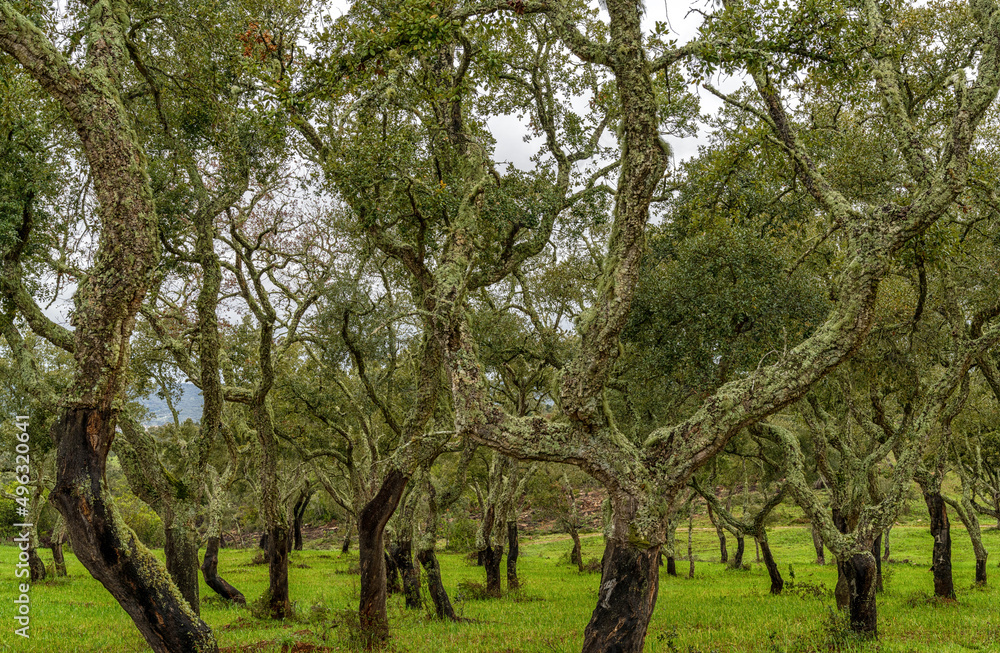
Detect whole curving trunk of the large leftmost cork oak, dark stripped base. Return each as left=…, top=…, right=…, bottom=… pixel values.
left=0, top=0, right=217, bottom=653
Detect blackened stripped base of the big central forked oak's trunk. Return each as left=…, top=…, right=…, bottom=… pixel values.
left=583, top=540, right=660, bottom=653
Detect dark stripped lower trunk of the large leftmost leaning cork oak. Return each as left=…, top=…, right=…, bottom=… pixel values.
left=50, top=408, right=218, bottom=653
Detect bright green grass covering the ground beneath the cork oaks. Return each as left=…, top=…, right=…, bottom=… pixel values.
left=0, top=525, right=1000, bottom=653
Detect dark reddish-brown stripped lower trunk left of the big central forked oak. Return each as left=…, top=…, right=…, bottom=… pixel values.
left=358, top=469, right=409, bottom=648
